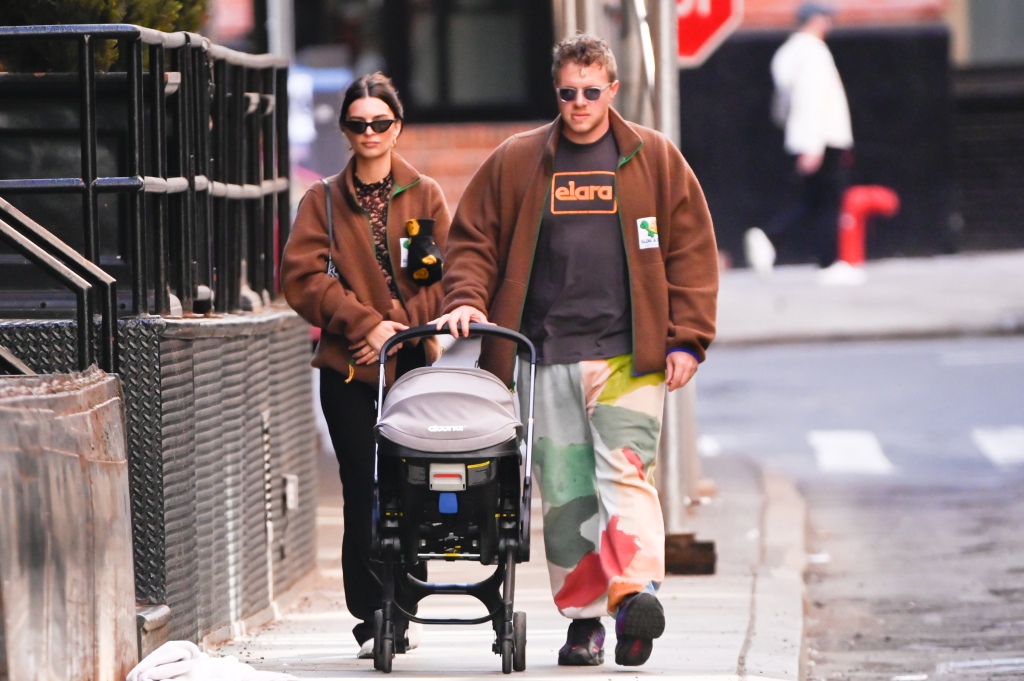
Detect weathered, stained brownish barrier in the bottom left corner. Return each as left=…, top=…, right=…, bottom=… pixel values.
left=0, top=369, right=138, bottom=681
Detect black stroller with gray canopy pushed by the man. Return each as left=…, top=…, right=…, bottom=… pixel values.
left=371, top=324, right=537, bottom=674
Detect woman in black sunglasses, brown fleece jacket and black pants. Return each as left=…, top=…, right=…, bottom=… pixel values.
left=282, top=73, right=451, bottom=657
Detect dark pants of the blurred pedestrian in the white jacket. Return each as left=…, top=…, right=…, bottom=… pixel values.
left=765, top=146, right=852, bottom=267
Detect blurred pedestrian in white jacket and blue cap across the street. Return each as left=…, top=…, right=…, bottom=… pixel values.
left=744, top=2, right=853, bottom=282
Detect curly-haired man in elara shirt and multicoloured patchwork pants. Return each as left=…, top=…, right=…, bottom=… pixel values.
left=437, top=35, right=718, bottom=666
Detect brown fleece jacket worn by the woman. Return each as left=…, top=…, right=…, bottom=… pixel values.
left=281, top=153, right=452, bottom=384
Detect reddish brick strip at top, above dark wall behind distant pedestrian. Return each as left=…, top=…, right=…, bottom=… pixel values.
left=742, top=0, right=947, bottom=29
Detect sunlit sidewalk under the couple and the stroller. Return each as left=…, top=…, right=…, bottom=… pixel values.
left=210, top=444, right=804, bottom=681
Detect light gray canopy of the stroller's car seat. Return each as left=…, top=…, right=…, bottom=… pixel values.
left=376, top=367, right=522, bottom=452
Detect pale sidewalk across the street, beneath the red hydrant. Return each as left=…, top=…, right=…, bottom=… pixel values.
left=713, top=251, right=1024, bottom=351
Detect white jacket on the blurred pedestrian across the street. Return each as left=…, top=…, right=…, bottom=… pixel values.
left=771, top=32, right=853, bottom=155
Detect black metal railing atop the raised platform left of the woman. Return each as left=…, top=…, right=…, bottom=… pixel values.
left=0, top=25, right=290, bottom=326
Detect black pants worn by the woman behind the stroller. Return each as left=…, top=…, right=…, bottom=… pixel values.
left=321, top=345, right=427, bottom=645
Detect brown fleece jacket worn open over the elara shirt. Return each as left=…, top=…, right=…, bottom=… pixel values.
left=442, top=110, right=718, bottom=383
